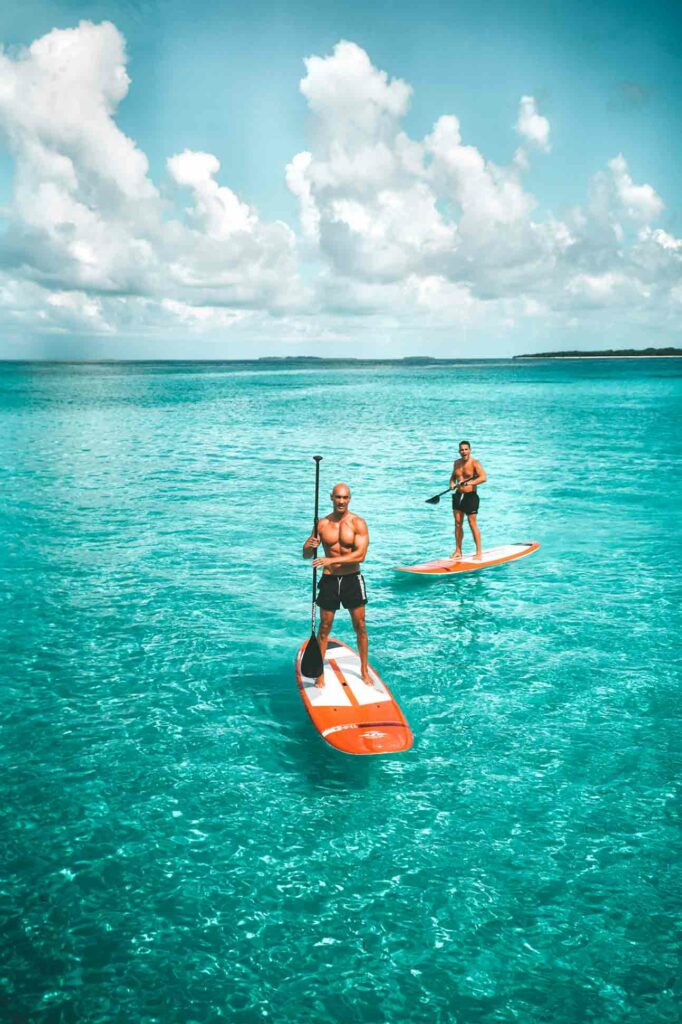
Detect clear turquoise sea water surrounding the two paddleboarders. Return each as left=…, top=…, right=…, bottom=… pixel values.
left=0, top=359, right=682, bottom=1024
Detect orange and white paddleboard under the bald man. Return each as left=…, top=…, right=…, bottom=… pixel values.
left=296, top=637, right=414, bottom=754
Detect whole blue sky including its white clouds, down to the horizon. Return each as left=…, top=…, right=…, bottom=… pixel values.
left=0, top=0, right=682, bottom=358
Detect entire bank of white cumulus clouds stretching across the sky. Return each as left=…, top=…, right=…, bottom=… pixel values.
left=0, top=22, right=682, bottom=356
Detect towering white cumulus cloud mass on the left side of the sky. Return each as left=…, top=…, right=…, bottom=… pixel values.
left=0, top=22, right=303, bottom=331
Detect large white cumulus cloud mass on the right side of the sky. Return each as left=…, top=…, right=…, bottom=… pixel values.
left=287, top=43, right=677, bottom=323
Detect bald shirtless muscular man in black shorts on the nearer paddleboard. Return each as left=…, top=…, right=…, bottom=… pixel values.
left=303, top=483, right=374, bottom=686
